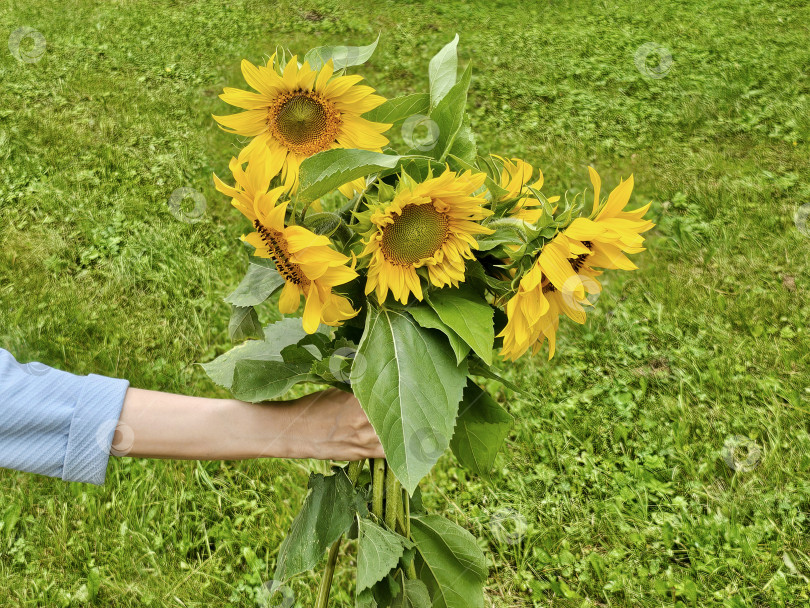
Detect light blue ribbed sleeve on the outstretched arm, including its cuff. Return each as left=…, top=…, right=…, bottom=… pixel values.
left=0, top=348, right=129, bottom=485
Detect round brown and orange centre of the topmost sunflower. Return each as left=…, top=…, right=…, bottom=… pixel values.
left=267, top=90, right=341, bottom=156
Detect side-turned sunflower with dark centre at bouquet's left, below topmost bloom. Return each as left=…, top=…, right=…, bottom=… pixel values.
left=237, top=186, right=358, bottom=334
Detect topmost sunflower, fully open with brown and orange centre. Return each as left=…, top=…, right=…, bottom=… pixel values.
left=214, top=55, right=391, bottom=191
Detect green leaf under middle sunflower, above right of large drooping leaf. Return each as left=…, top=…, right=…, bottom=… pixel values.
left=428, top=287, right=495, bottom=365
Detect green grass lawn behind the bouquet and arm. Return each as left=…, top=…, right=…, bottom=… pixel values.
left=0, top=0, right=810, bottom=607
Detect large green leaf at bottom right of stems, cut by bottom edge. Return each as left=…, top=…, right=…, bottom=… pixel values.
left=411, top=515, right=489, bottom=608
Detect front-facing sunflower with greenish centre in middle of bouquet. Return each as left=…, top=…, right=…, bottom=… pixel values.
left=361, top=170, right=492, bottom=304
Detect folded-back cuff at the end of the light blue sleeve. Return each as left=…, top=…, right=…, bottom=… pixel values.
left=62, top=374, right=129, bottom=485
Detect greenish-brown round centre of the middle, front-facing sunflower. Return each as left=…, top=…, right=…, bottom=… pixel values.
left=382, top=203, right=450, bottom=266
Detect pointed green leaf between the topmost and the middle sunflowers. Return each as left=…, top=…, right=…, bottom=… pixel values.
left=298, top=148, right=402, bottom=202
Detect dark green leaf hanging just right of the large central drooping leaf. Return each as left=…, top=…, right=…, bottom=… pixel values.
left=450, top=380, right=514, bottom=477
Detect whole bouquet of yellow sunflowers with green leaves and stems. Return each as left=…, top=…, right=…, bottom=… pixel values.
left=205, top=36, right=653, bottom=608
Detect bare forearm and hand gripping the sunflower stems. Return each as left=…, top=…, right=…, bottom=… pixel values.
left=112, top=388, right=384, bottom=460
